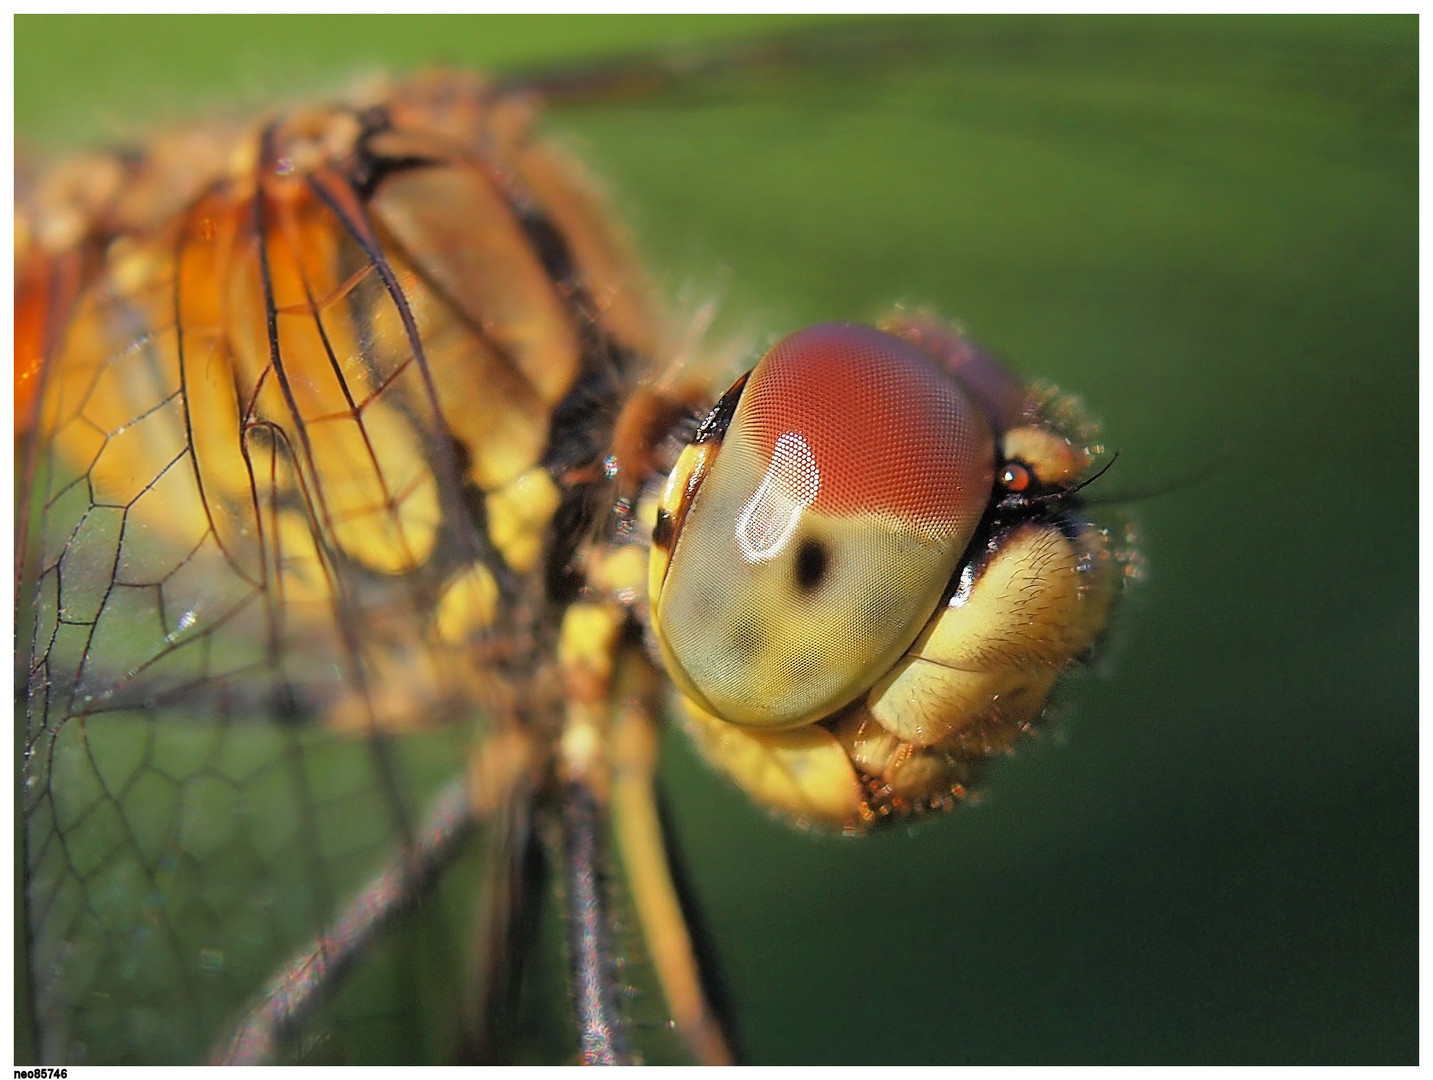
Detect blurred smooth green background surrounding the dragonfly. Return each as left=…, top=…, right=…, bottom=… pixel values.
left=14, top=17, right=1417, bottom=1063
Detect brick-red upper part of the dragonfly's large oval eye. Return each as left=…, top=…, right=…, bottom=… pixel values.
left=739, top=324, right=995, bottom=544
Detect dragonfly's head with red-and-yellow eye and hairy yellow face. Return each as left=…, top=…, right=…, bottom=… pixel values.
left=648, top=317, right=1132, bottom=831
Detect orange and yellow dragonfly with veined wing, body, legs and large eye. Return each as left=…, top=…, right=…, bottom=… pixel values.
left=16, top=48, right=1134, bottom=1063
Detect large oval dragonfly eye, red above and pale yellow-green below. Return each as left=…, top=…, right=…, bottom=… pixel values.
left=653, top=324, right=995, bottom=728
